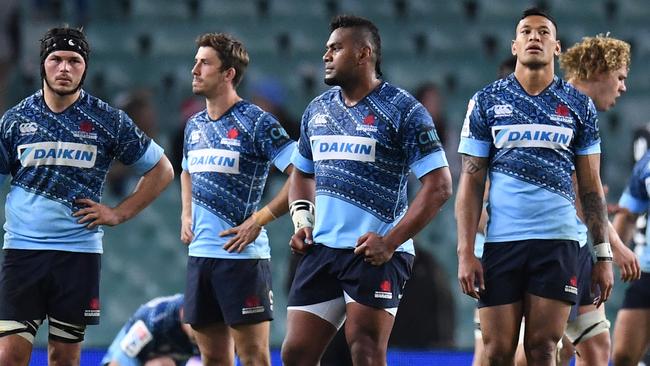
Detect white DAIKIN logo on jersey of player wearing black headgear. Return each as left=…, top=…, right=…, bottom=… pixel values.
left=18, top=141, right=97, bottom=168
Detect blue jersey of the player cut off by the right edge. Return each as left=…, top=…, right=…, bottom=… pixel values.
left=618, top=152, right=650, bottom=272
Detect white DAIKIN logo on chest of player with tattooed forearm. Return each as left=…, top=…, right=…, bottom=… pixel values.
left=492, top=124, right=573, bottom=150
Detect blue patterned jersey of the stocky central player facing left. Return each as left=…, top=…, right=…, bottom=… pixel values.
left=292, top=82, right=447, bottom=253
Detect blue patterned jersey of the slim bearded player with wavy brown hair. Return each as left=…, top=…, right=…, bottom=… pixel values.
left=183, top=101, right=295, bottom=259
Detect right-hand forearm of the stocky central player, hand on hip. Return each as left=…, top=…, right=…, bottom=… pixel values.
left=384, top=167, right=452, bottom=248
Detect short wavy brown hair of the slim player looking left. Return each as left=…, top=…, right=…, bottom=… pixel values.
left=196, top=33, right=249, bottom=87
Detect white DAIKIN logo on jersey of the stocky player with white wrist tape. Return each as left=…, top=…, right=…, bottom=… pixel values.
left=310, top=135, right=377, bottom=161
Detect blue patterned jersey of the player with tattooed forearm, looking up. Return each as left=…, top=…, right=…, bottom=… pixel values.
left=458, top=74, right=600, bottom=242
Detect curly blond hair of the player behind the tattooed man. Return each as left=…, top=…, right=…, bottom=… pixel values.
left=560, top=34, right=630, bottom=80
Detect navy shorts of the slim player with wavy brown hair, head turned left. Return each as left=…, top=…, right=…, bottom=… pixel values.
left=184, top=257, right=273, bottom=326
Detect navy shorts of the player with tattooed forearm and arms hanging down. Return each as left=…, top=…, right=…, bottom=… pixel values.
left=478, top=240, right=579, bottom=308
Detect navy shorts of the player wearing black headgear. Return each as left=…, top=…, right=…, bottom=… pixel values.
left=0, top=249, right=101, bottom=325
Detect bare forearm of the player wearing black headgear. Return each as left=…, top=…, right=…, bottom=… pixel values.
left=115, top=155, right=174, bottom=222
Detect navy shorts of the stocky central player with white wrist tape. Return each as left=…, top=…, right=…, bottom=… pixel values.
left=288, top=245, right=415, bottom=309
